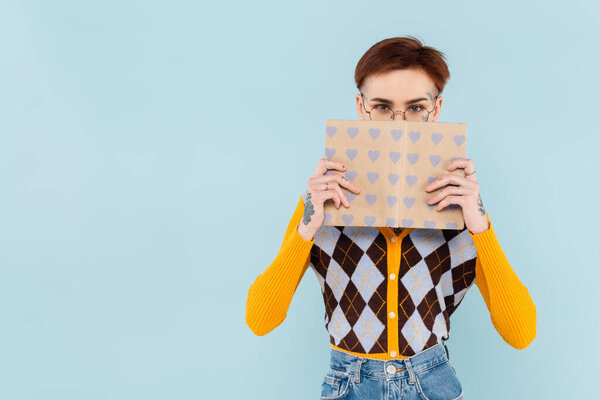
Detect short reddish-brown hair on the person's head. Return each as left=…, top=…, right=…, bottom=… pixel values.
left=354, top=36, right=450, bottom=94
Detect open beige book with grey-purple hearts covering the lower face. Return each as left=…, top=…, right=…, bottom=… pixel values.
left=323, top=119, right=467, bottom=229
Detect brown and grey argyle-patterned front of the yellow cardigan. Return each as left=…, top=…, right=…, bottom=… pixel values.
left=310, top=225, right=477, bottom=357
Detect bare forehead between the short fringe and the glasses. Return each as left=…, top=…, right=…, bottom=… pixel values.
left=364, top=69, right=435, bottom=103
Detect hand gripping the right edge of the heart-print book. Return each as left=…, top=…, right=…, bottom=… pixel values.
left=425, top=158, right=490, bottom=235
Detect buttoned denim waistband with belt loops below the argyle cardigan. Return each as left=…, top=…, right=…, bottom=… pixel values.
left=329, top=339, right=449, bottom=382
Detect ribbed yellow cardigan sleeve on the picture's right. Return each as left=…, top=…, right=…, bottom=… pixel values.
left=469, top=214, right=537, bottom=350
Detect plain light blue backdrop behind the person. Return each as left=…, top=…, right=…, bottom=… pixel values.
left=0, top=0, right=600, bottom=400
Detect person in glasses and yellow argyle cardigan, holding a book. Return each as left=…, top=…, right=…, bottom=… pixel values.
left=246, top=36, right=536, bottom=400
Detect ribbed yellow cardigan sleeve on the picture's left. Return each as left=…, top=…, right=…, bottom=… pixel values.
left=246, top=196, right=315, bottom=336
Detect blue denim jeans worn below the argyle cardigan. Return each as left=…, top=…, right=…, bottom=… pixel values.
left=321, top=340, right=463, bottom=400
